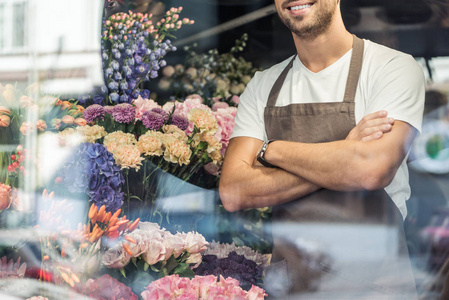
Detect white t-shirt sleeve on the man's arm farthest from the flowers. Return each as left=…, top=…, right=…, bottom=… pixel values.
left=367, top=55, right=425, bottom=131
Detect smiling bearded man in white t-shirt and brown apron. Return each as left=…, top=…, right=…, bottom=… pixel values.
left=220, top=0, right=425, bottom=299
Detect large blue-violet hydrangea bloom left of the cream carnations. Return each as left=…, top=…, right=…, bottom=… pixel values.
left=62, top=143, right=125, bottom=212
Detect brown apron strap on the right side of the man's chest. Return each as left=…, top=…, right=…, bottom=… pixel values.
left=343, top=35, right=364, bottom=102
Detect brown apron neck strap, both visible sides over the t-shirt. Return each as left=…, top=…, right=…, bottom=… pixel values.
left=267, top=35, right=364, bottom=107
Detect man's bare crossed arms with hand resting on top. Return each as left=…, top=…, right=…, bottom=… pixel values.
left=219, top=111, right=416, bottom=211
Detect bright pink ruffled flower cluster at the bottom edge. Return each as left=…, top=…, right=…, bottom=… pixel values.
left=141, top=275, right=266, bottom=300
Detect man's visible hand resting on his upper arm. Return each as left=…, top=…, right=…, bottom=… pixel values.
left=346, top=110, right=394, bottom=142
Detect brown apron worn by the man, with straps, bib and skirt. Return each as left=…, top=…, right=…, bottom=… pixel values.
left=264, top=36, right=416, bottom=300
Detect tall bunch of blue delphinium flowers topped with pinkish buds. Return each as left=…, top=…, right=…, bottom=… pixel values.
left=94, top=7, right=193, bottom=105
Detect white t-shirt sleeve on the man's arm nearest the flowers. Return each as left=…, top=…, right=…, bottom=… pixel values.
left=231, top=73, right=265, bottom=140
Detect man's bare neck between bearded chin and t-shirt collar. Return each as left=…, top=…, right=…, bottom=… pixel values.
left=293, top=14, right=353, bottom=73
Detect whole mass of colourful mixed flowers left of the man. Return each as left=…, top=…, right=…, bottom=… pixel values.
left=0, top=1, right=266, bottom=299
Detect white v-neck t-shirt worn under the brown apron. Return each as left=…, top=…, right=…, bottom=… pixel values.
left=231, top=40, right=425, bottom=218
